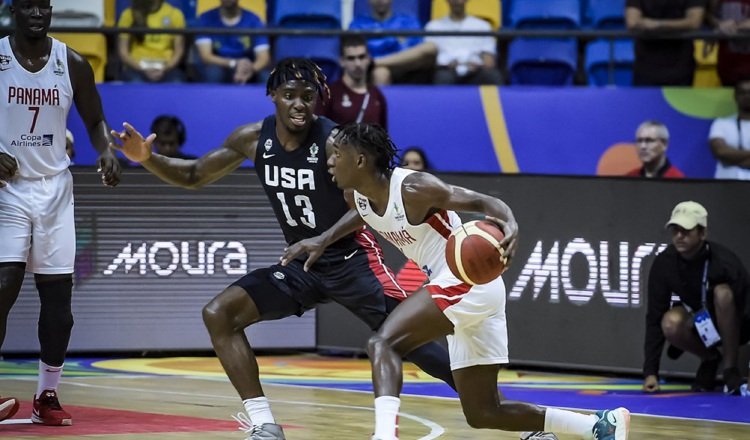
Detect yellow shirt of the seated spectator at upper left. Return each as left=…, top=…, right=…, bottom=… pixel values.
left=117, top=1, right=185, bottom=63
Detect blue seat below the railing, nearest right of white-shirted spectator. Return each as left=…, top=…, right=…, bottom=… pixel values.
left=508, top=38, right=578, bottom=86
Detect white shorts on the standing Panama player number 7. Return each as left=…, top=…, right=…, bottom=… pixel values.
left=0, top=170, right=76, bottom=275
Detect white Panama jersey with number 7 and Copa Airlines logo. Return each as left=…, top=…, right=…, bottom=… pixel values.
left=0, top=37, right=73, bottom=178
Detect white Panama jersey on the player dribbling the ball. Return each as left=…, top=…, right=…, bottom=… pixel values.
left=354, top=168, right=461, bottom=279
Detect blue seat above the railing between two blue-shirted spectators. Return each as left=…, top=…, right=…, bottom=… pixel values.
left=273, top=0, right=341, bottom=29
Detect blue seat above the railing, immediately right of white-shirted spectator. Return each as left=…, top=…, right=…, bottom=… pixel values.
left=508, top=0, right=581, bottom=29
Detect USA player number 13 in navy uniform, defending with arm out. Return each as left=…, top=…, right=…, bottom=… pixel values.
left=113, top=59, right=453, bottom=439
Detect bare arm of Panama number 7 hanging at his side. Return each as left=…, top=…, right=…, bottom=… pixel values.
left=68, top=48, right=122, bottom=186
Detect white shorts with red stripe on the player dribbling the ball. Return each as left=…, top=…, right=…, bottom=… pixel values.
left=425, top=271, right=508, bottom=370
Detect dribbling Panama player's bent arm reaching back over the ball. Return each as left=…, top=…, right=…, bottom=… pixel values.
left=403, top=172, right=518, bottom=259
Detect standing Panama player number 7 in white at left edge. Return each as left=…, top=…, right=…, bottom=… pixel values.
left=0, top=0, right=120, bottom=425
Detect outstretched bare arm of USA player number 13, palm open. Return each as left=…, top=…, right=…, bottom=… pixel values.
left=112, top=122, right=261, bottom=189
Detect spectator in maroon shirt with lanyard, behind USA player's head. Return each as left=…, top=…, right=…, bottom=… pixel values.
left=317, top=35, right=388, bottom=129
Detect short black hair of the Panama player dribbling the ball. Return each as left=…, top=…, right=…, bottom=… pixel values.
left=336, top=122, right=398, bottom=175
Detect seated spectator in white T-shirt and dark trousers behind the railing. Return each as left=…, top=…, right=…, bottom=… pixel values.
left=425, top=0, right=502, bottom=84
